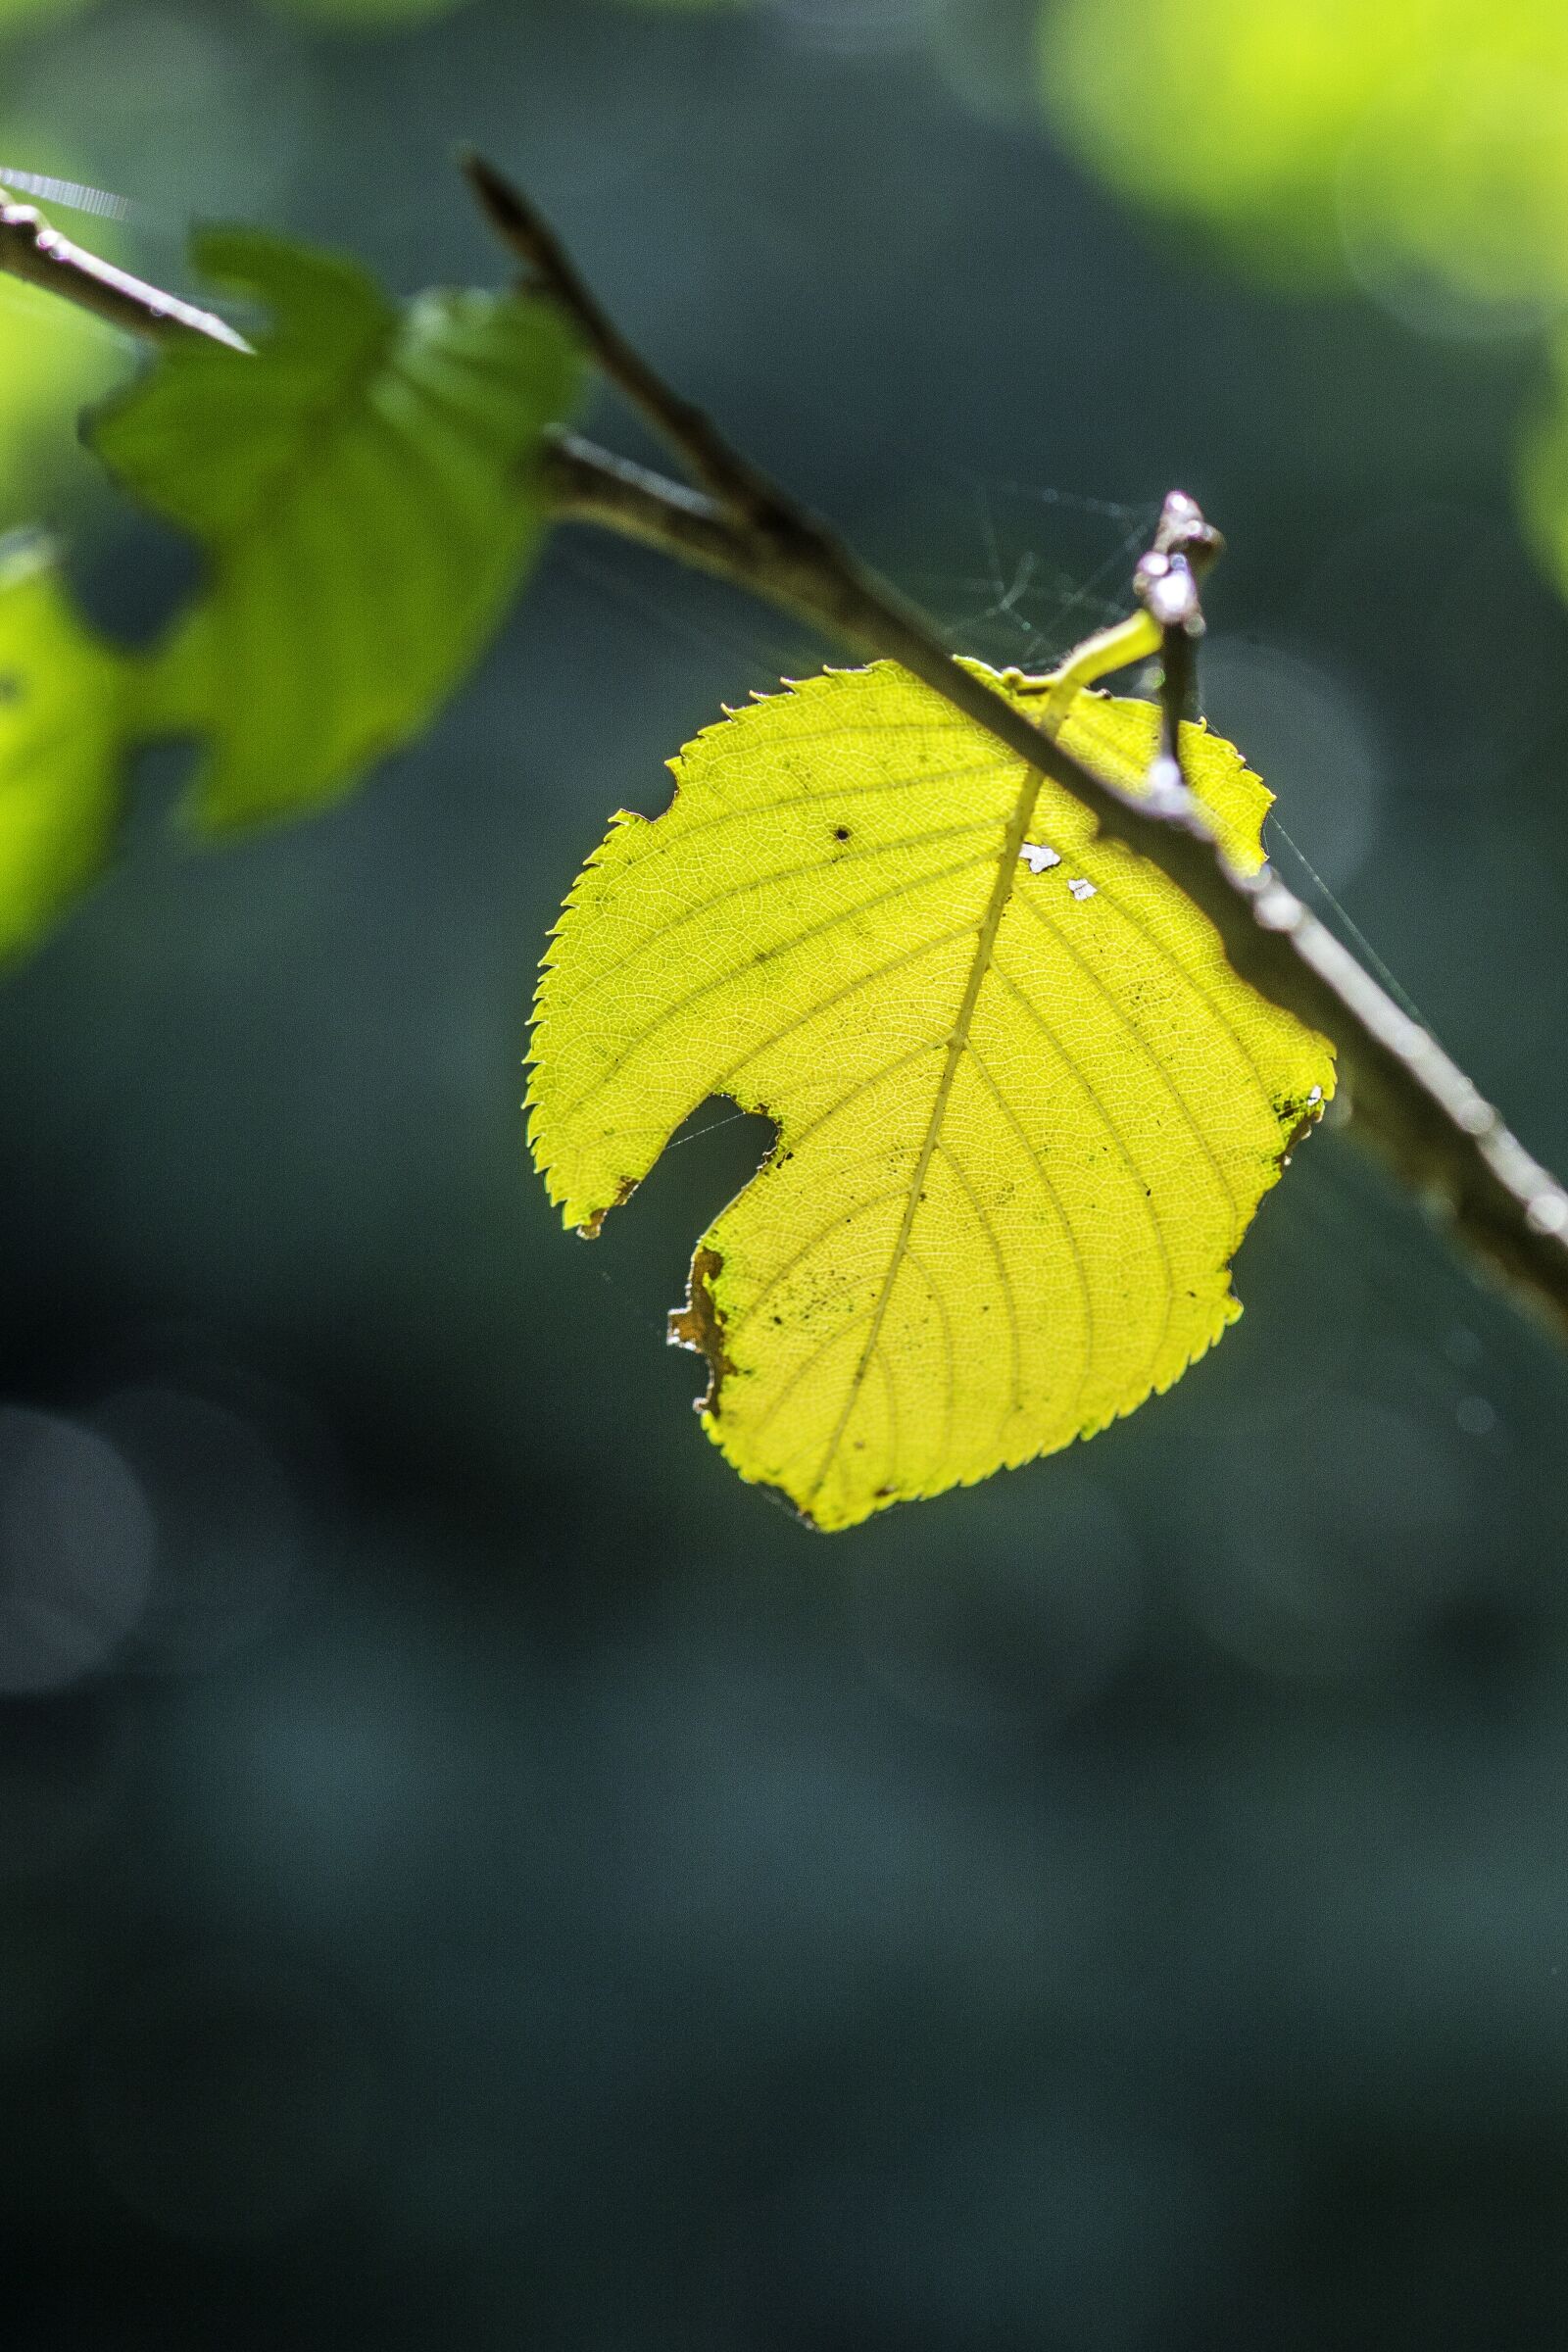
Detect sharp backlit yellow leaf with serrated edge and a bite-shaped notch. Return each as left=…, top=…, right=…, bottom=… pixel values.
left=529, top=663, right=1333, bottom=1529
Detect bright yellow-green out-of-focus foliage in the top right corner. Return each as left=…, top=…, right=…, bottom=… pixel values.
left=1042, top=0, right=1568, bottom=331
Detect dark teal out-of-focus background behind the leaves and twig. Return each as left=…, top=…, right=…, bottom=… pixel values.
left=0, top=0, right=1568, bottom=2352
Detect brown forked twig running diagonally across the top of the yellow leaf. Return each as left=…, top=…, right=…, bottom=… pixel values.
left=12, top=158, right=1568, bottom=1339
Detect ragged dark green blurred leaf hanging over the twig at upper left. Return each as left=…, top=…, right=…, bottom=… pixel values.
left=92, top=230, right=578, bottom=828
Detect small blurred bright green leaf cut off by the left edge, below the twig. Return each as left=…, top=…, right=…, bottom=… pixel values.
left=0, top=539, right=127, bottom=955
